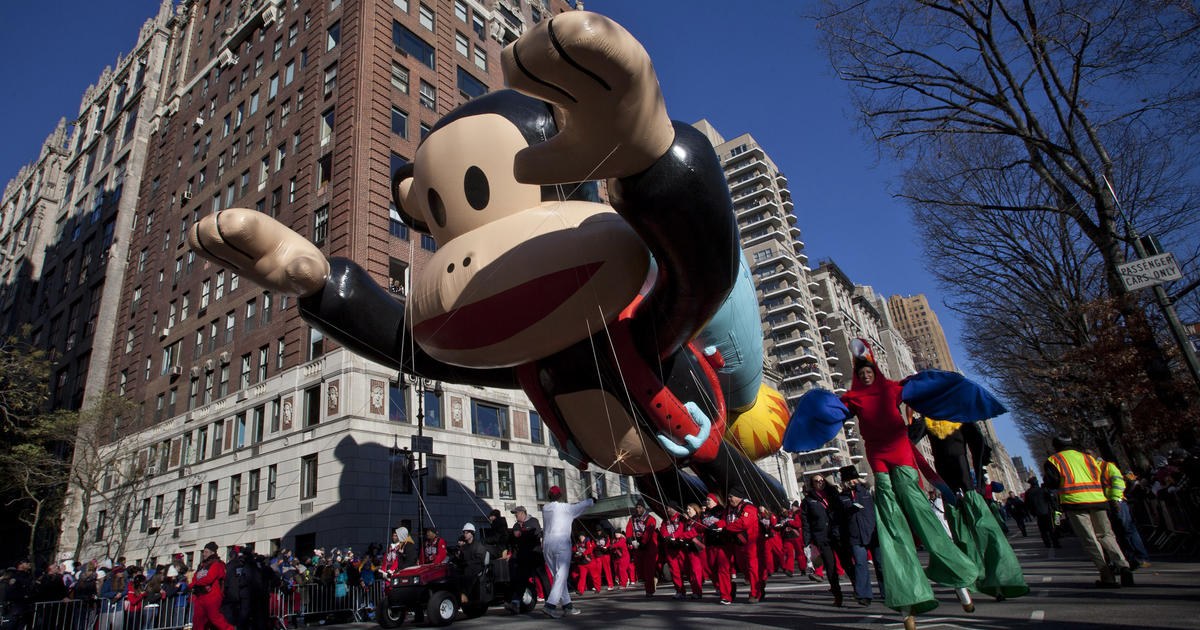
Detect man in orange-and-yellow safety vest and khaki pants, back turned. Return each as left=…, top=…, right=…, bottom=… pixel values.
left=1042, top=436, right=1133, bottom=588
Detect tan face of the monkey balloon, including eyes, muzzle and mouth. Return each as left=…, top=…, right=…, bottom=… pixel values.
left=397, top=114, right=649, bottom=368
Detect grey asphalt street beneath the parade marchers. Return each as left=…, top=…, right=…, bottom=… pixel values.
left=316, top=528, right=1200, bottom=630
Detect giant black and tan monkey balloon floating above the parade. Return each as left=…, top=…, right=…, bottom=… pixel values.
left=188, top=11, right=786, bottom=516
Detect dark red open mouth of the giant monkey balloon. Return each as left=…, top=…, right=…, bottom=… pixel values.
left=413, top=263, right=604, bottom=350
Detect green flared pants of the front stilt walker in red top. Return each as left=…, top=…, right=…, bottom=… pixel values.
left=875, top=466, right=979, bottom=614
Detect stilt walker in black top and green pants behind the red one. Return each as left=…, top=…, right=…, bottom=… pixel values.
left=908, top=418, right=1030, bottom=600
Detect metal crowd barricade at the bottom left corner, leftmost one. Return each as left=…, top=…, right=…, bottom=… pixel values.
left=30, top=595, right=192, bottom=630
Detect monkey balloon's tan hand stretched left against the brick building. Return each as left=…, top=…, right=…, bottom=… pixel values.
left=187, top=208, right=329, bottom=296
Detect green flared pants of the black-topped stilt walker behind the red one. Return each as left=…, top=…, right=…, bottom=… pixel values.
left=947, top=491, right=1030, bottom=598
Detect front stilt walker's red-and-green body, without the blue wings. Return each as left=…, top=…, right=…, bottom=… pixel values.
left=841, top=340, right=979, bottom=628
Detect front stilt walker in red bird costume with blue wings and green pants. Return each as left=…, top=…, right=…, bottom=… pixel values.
left=784, top=340, right=1004, bottom=629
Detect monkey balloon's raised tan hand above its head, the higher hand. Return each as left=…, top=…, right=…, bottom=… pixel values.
left=500, top=11, right=674, bottom=185
